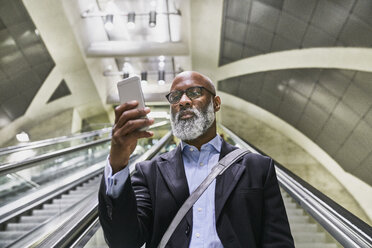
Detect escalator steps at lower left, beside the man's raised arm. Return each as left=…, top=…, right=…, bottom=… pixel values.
left=0, top=176, right=101, bottom=248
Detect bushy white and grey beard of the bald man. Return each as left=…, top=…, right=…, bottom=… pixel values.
left=171, top=101, right=215, bottom=140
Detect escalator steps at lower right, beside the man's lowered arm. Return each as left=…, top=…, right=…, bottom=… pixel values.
left=280, top=189, right=342, bottom=248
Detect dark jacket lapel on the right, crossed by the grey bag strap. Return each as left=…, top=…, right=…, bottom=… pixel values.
left=215, top=141, right=245, bottom=221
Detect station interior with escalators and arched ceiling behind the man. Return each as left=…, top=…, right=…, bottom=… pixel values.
left=0, top=0, right=372, bottom=248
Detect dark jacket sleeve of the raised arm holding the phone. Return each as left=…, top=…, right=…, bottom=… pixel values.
left=98, top=165, right=153, bottom=248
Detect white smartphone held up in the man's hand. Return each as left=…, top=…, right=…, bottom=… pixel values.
left=117, top=76, right=148, bottom=131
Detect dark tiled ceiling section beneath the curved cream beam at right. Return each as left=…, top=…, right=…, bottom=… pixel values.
left=218, top=68, right=372, bottom=184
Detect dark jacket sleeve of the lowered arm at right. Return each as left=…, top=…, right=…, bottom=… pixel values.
left=262, top=160, right=294, bottom=248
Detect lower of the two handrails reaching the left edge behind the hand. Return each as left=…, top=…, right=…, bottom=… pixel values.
left=0, top=137, right=111, bottom=176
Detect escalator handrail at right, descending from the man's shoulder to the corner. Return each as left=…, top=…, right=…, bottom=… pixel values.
left=221, top=125, right=372, bottom=247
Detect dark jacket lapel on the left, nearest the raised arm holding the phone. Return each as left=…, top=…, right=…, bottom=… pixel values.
left=157, top=145, right=192, bottom=224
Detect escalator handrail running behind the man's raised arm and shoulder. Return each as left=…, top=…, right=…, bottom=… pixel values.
left=35, top=131, right=173, bottom=248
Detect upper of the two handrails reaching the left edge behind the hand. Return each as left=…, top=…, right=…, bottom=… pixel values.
left=0, top=127, right=111, bottom=156
